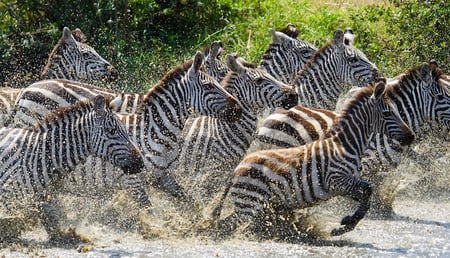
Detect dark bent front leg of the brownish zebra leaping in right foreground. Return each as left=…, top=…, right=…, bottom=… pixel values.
left=331, top=180, right=372, bottom=236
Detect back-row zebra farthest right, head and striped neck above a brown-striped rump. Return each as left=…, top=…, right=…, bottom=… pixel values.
left=291, top=30, right=381, bottom=110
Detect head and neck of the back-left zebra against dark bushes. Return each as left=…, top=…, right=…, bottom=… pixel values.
left=41, top=27, right=117, bottom=82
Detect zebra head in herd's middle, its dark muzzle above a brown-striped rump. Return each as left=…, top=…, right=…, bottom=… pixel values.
left=222, top=55, right=298, bottom=111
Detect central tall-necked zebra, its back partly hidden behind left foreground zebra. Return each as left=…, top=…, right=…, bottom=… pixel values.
left=9, top=52, right=241, bottom=212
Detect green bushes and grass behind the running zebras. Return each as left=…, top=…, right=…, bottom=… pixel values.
left=0, top=0, right=450, bottom=91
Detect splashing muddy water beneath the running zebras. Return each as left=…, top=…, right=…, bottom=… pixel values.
left=0, top=138, right=450, bottom=257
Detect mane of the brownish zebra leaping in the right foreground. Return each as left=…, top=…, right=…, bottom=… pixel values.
left=327, top=84, right=375, bottom=133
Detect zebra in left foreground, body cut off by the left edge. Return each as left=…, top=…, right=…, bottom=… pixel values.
left=0, top=96, right=144, bottom=239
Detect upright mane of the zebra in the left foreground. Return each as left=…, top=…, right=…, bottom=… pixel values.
left=33, top=96, right=111, bottom=131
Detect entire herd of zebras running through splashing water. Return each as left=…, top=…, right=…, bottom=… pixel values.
left=0, top=24, right=450, bottom=242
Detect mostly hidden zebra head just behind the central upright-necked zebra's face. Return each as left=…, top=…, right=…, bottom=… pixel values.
left=204, top=41, right=230, bottom=82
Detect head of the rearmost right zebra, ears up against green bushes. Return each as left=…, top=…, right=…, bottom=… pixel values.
left=332, top=30, right=382, bottom=87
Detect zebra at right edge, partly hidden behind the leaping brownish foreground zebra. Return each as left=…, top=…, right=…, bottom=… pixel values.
left=256, top=62, right=450, bottom=218
